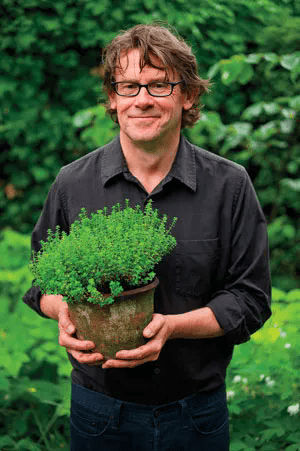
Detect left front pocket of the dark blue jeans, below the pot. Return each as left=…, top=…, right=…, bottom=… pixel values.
left=70, top=405, right=110, bottom=436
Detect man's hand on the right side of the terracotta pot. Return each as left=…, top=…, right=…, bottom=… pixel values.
left=102, top=313, right=172, bottom=369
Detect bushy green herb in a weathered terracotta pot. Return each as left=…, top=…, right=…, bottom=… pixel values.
left=30, top=200, right=176, bottom=359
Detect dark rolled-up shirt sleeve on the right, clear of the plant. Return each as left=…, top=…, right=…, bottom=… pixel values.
left=208, top=172, right=271, bottom=344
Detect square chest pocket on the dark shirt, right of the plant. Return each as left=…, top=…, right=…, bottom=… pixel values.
left=176, top=238, right=220, bottom=296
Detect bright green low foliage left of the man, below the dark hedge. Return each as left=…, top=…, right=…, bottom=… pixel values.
left=0, top=233, right=70, bottom=451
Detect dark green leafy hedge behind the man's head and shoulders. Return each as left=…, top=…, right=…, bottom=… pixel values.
left=0, top=0, right=300, bottom=290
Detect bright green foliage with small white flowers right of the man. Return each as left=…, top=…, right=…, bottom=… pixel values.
left=227, top=289, right=300, bottom=451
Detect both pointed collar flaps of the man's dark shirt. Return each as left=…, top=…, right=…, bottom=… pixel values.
left=101, top=135, right=196, bottom=191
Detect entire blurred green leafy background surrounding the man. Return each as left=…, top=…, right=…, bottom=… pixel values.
left=0, top=0, right=300, bottom=451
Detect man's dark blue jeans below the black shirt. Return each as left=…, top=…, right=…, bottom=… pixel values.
left=70, top=384, right=229, bottom=451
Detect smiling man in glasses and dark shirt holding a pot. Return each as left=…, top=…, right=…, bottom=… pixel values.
left=24, top=25, right=271, bottom=451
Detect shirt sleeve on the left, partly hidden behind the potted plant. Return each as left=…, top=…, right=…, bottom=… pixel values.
left=23, top=179, right=69, bottom=318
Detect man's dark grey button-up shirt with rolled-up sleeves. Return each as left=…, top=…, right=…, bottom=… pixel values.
left=24, top=137, right=271, bottom=405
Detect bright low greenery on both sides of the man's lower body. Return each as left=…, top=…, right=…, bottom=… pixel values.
left=0, top=229, right=300, bottom=451
